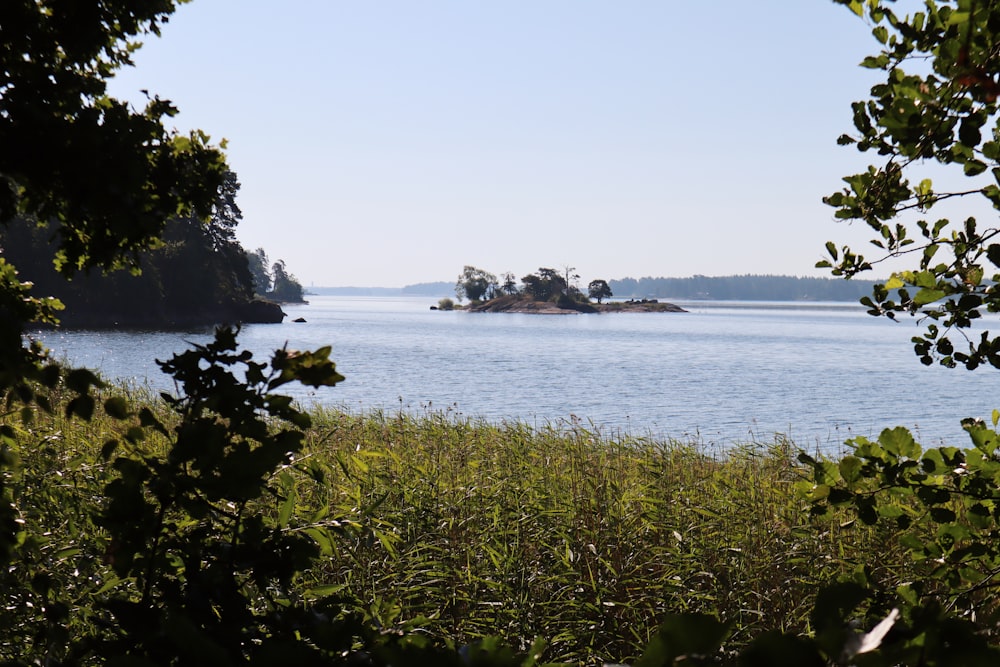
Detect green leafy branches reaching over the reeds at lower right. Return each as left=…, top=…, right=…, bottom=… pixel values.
left=803, top=413, right=1000, bottom=627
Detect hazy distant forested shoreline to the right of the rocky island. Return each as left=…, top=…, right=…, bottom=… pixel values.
left=608, top=275, right=873, bottom=301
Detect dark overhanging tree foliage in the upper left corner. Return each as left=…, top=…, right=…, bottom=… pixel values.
left=0, top=0, right=225, bottom=274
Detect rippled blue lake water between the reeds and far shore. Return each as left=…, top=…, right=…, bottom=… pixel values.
left=27, top=296, right=1000, bottom=449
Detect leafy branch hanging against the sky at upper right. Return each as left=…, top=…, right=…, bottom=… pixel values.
left=818, top=0, right=1000, bottom=369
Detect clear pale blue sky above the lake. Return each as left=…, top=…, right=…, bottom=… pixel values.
left=110, top=0, right=892, bottom=287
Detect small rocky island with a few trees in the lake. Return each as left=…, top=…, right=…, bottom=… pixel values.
left=431, top=266, right=686, bottom=315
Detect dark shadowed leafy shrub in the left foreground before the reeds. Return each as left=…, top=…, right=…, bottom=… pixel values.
left=7, top=329, right=351, bottom=665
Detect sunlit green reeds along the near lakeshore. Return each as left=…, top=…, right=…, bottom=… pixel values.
left=0, top=388, right=904, bottom=663
